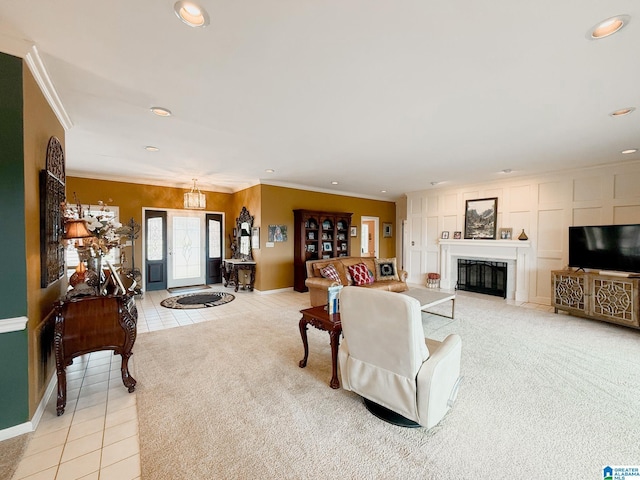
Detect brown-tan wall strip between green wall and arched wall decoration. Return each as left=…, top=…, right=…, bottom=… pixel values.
left=22, top=62, right=66, bottom=417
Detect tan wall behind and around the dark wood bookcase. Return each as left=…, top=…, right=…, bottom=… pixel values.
left=256, top=185, right=396, bottom=290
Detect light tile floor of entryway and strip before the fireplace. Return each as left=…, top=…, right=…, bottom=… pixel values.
left=13, top=286, right=553, bottom=480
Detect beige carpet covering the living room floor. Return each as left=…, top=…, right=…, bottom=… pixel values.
left=134, top=296, right=640, bottom=480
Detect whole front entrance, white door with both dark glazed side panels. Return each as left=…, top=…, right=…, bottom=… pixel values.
left=143, top=210, right=224, bottom=291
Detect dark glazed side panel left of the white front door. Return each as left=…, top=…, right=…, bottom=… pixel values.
left=144, top=210, right=167, bottom=291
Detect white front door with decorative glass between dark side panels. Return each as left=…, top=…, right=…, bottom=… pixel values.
left=167, top=211, right=206, bottom=288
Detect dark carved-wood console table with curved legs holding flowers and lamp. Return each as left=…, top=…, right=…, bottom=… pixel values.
left=53, top=293, right=138, bottom=415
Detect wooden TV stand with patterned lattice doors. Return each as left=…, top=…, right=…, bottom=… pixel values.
left=551, top=270, right=640, bottom=328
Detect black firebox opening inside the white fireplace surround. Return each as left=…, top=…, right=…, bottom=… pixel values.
left=456, top=258, right=507, bottom=298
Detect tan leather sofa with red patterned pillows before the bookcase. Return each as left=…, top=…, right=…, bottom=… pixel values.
left=305, top=257, right=409, bottom=307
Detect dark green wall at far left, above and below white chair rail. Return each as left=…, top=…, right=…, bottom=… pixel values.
left=0, top=53, right=29, bottom=429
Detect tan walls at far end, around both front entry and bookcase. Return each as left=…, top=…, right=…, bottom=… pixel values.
left=67, top=177, right=396, bottom=291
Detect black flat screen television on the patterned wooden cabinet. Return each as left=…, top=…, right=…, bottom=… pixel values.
left=569, top=224, right=640, bottom=273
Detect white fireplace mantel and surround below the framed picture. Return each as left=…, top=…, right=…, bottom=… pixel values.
left=439, top=240, right=531, bottom=302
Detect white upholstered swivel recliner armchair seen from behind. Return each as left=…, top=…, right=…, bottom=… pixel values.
left=338, top=287, right=462, bottom=428
